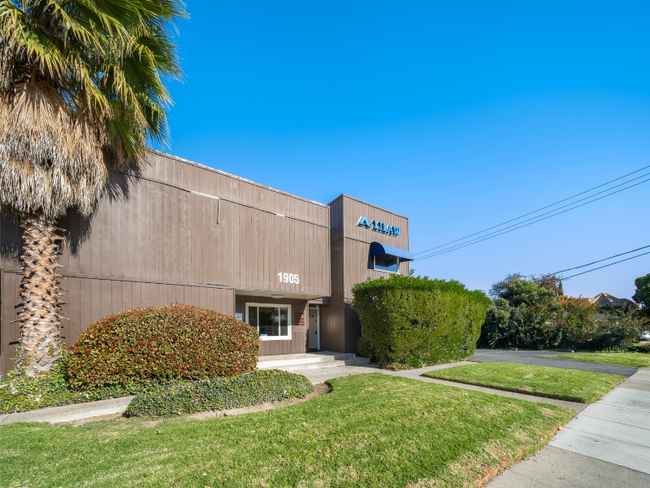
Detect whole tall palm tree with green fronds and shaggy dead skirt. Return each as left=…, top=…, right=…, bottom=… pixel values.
left=0, top=0, right=187, bottom=375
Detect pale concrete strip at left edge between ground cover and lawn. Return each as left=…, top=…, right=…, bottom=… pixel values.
left=0, top=396, right=135, bottom=425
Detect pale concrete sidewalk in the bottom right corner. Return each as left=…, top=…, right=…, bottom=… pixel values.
left=487, top=369, right=650, bottom=488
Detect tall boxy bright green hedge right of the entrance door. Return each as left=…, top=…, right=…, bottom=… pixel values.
left=352, top=275, right=490, bottom=368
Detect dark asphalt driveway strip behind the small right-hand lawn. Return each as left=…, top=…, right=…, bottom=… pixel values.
left=468, top=349, right=638, bottom=378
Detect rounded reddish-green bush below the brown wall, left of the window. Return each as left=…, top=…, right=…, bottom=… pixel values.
left=64, top=304, right=260, bottom=389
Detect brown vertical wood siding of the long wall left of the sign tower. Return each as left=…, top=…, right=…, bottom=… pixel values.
left=0, top=153, right=331, bottom=374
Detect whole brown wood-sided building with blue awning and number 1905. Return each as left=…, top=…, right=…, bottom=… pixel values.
left=0, top=153, right=412, bottom=374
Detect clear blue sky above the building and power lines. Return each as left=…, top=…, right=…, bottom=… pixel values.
left=161, top=0, right=650, bottom=297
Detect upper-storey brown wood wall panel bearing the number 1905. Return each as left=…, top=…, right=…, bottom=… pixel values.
left=39, top=154, right=330, bottom=296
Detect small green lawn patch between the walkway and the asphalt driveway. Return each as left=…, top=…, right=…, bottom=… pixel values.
left=423, top=363, right=625, bottom=403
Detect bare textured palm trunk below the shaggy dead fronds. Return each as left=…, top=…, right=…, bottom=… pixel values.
left=16, top=213, right=61, bottom=376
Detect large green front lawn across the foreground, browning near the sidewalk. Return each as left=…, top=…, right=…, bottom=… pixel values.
left=0, top=373, right=574, bottom=488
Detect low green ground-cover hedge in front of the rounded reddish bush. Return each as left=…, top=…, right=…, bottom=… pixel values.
left=125, top=370, right=314, bottom=417
